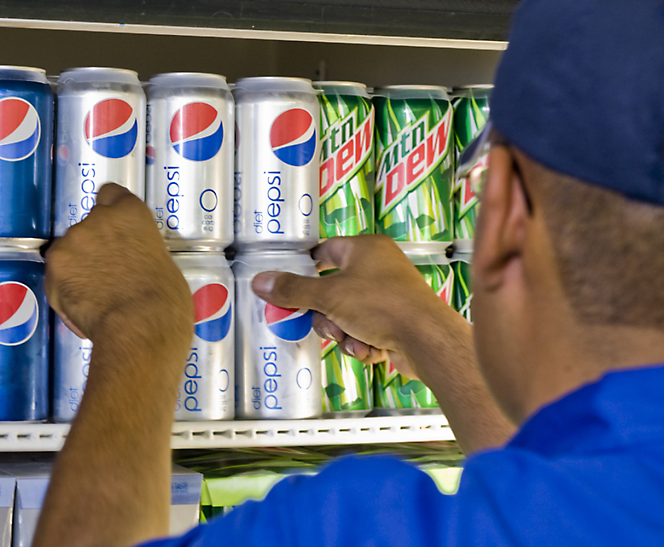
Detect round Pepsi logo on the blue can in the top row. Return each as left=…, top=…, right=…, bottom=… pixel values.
left=0, top=97, right=41, bottom=161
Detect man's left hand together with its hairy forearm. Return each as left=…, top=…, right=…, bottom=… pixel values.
left=33, top=184, right=194, bottom=547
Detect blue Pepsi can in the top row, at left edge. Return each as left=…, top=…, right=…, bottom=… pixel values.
left=0, top=66, right=53, bottom=239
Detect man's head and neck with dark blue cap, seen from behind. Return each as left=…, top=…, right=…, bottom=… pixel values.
left=474, top=0, right=664, bottom=420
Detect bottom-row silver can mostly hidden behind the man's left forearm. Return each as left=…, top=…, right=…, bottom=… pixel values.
left=53, top=314, right=92, bottom=422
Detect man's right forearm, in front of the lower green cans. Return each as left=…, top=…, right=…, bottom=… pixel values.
left=401, top=299, right=516, bottom=453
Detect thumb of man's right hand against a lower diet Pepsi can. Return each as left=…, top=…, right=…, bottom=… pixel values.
left=251, top=272, right=325, bottom=313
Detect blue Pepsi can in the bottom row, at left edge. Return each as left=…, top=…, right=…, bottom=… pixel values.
left=0, top=247, right=49, bottom=422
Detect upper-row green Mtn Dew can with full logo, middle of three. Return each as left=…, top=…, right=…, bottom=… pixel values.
left=373, top=86, right=454, bottom=242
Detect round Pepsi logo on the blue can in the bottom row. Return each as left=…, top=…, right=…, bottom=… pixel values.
left=0, top=281, right=39, bottom=346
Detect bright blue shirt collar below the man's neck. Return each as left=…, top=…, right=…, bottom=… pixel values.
left=507, top=364, right=664, bottom=457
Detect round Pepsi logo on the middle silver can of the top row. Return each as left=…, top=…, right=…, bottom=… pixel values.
left=170, top=103, right=224, bottom=161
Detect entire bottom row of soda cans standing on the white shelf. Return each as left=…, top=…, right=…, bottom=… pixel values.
left=0, top=241, right=472, bottom=422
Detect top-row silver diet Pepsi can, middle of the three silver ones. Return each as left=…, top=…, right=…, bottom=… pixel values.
left=146, top=72, right=235, bottom=250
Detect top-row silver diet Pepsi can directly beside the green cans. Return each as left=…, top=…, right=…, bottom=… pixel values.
left=233, top=78, right=320, bottom=251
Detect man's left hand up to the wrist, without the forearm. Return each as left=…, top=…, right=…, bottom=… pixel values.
left=46, top=184, right=193, bottom=343
